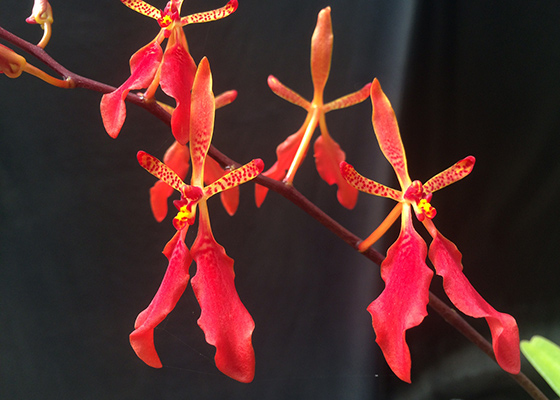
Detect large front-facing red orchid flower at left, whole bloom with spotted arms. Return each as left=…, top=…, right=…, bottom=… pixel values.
left=130, top=58, right=264, bottom=382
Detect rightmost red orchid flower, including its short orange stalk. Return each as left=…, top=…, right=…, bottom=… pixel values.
left=340, top=79, right=520, bottom=382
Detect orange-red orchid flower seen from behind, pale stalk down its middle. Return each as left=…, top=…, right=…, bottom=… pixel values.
left=255, top=7, right=370, bottom=209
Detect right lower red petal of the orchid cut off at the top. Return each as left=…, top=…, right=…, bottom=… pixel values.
left=160, top=36, right=196, bottom=144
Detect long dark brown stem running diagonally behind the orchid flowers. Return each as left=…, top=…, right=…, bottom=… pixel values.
left=0, top=23, right=548, bottom=400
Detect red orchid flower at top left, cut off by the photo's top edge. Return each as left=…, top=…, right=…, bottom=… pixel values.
left=101, top=0, right=237, bottom=144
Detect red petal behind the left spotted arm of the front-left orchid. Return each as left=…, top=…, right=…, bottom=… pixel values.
left=150, top=142, right=190, bottom=222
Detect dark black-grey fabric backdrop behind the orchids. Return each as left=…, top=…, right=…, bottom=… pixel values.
left=0, top=0, right=560, bottom=400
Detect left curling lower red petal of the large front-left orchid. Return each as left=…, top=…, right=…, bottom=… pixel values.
left=130, top=229, right=192, bottom=368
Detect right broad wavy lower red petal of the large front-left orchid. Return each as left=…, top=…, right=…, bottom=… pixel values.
left=191, top=208, right=255, bottom=382
